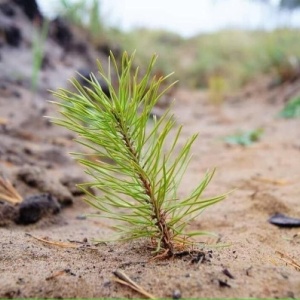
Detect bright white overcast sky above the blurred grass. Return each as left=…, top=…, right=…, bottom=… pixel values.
left=38, top=0, right=300, bottom=37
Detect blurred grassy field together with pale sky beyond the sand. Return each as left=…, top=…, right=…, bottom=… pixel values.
left=32, top=0, right=300, bottom=92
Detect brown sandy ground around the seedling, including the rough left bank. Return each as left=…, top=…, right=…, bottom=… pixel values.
left=0, top=1, right=300, bottom=298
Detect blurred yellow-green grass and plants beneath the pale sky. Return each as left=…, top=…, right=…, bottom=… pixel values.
left=55, top=0, right=300, bottom=91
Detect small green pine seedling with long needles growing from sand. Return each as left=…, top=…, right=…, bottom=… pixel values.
left=54, top=52, right=225, bottom=256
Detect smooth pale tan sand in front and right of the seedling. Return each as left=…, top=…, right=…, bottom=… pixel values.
left=0, top=82, right=300, bottom=297
